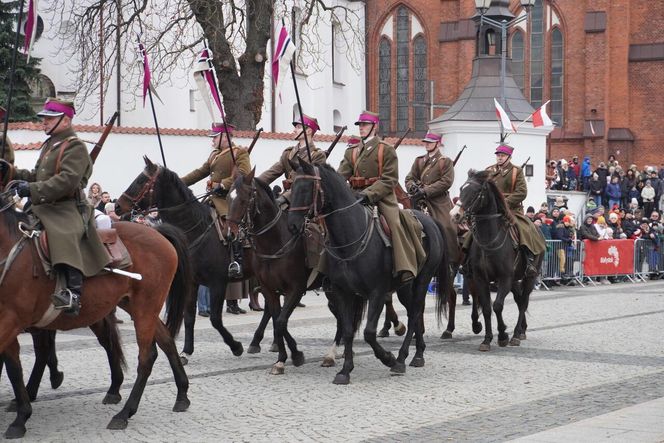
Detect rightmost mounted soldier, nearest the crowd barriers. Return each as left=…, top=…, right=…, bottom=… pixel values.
left=457, top=143, right=546, bottom=277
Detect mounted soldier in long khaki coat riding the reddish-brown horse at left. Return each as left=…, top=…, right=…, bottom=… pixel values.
left=2, top=98, right=110, bottom=315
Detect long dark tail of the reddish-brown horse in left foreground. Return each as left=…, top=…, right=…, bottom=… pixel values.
left=156, top=224, right=194, bottom=337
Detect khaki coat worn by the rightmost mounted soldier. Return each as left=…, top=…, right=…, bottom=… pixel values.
left=486, top=162, right=546, bottom=255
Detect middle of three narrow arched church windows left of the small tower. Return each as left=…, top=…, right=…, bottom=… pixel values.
left=397, top=6, right=410, bottom=132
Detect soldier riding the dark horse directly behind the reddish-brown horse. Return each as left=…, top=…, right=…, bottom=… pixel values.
left=182, top=123, right=251, bottom=278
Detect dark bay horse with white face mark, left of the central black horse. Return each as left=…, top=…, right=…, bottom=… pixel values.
left=228, top=170, right=311, bottom=375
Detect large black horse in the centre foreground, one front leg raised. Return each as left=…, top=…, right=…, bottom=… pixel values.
left=288, top=160, right=451, bottom=384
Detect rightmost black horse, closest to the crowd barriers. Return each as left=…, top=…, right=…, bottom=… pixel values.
left=452, top=170, right=543, bottom=351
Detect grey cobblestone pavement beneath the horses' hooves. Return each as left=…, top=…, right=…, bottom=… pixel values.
left=0, top=282, right=664, bottom=442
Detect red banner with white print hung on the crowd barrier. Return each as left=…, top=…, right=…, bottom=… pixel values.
left=583, top=239, right=634, bottom=276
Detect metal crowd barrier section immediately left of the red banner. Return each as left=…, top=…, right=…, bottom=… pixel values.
left=540, top=240, right=584, bottom=290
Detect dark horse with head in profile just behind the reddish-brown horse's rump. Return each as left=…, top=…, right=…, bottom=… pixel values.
left=116, top=157, right=252, bottom=363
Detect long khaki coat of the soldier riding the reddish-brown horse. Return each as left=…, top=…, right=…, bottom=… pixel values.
left=14, top=129, right=111, bottom=277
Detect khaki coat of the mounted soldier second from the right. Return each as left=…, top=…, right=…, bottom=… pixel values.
left=406, top=150, right=460, bottom=263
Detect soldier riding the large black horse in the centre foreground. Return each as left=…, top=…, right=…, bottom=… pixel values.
left=337, top=111, right=425, bottom=284
